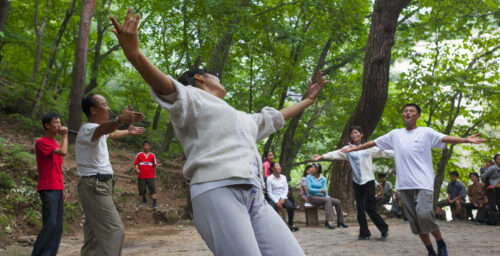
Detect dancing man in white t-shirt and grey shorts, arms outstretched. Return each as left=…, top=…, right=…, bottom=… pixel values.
left=342, top=104, right=486, bottom=256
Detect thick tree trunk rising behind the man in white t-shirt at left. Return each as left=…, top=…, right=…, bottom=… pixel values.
left=68, top=0, right=95, bottom=144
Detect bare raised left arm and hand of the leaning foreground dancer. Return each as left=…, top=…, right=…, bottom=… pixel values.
left=109, top=8, right=175, bottom=95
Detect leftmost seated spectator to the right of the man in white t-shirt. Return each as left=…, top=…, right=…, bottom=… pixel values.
left=436, top=171, right=465, bottom=220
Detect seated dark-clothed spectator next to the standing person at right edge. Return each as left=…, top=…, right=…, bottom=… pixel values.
left=465, top=172, right=488, bottom=222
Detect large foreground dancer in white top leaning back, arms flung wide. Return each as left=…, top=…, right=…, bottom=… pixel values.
left=110, top=9, right=328, bottom=256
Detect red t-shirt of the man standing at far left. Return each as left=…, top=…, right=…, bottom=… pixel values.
left=35, top=137, right=64, bottom=191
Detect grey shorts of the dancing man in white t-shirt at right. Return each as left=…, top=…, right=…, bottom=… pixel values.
left=399, top=189, right=439, bottom=234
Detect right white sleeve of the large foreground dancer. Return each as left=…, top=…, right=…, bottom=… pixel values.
left=250, top=107, right=285, bottom=141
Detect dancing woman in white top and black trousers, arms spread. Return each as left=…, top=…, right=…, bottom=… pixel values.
left=311, top=126, right=394, bottom=240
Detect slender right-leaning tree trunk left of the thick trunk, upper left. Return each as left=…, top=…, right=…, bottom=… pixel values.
left=31, top=0, right=76, bottom=118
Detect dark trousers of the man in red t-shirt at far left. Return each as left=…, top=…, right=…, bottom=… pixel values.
left=31, top=190, right=63, bottom=256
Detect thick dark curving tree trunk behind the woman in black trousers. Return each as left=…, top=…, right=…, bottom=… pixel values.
left=329, top=0, right=411, bottom=210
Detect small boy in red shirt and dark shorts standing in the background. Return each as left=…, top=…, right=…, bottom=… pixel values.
left=134, top=141, right=157, bottom=209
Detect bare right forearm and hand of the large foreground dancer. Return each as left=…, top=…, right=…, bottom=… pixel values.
left=280, top=70, right=330, bottom=120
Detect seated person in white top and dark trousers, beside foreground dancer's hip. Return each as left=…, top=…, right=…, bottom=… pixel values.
left=266, top=162, right=299, bottom=232
